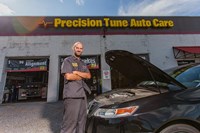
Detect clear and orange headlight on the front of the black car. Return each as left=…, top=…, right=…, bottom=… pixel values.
left=94, top=106, right=139, bottom=118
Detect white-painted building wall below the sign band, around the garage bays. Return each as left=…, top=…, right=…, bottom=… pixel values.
left=0, top=34, right=200, bottom=102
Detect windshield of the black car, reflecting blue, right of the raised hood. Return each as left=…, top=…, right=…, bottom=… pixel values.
left=165, top=65, right=200, bottom=88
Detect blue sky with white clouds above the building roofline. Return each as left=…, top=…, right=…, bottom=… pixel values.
left=0, top=0, right=200, bottom=16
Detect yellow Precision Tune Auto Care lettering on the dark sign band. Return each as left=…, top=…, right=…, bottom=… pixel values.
left=53, top=18, right=174, bottom=28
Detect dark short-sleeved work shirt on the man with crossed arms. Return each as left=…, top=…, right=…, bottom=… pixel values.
left=61, top=56, right=91, bottom=98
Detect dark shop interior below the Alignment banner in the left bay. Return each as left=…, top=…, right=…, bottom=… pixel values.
left=3, top=71, right=48, bottom=103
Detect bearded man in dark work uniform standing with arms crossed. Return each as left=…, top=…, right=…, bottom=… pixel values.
left=61, top=42, right=91, bottom=133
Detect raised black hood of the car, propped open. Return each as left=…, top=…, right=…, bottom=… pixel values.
left=105, top=50, right=186, bottom=89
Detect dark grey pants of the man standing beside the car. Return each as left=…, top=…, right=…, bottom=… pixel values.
left=61, top=98, right=87, bottom=133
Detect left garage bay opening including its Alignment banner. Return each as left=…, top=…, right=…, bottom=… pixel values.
left=3, top=58, right=48, bottom=103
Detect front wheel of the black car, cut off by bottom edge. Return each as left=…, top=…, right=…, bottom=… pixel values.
left=160, top=124, right=200, bottom=133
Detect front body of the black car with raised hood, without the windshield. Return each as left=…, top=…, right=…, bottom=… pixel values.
left=86, top=50, right=200, bottom=133
